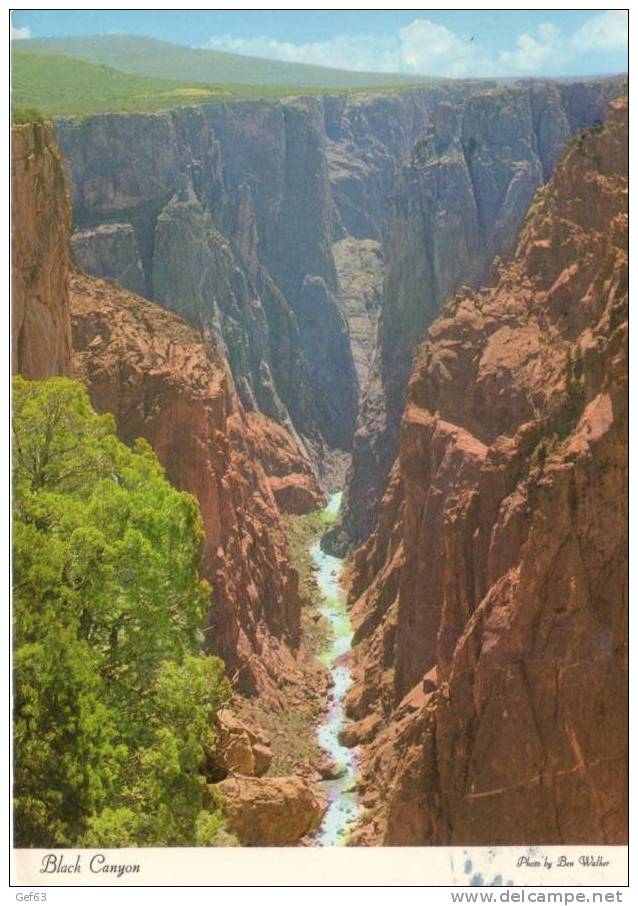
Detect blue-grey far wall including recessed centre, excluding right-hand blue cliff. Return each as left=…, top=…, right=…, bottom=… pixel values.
left=52, top=83, right=484, bottom=470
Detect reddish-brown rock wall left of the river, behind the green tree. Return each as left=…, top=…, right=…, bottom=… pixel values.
left=12, top=124, right=323, bottom=705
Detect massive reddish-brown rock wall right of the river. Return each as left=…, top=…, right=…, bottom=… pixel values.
left=347, top=100, right=628, bottom=845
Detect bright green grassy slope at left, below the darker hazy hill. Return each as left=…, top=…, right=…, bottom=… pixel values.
left=12, top=49, right=364, bottom=119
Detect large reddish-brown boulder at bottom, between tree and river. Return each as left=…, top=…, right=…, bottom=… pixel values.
left=215, top=777, right=325, bottom=846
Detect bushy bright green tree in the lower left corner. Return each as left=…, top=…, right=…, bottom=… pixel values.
left=13, top=377, right=230, bottom=847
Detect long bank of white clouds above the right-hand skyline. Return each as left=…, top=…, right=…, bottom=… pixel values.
left=207, top=10, right=628, bottom=78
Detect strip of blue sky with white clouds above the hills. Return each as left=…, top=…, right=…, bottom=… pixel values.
left=11, top=10, right=628, bottom=78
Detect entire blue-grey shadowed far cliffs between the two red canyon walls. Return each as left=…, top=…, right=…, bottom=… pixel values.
left=57, top=82, right=612, bottom=480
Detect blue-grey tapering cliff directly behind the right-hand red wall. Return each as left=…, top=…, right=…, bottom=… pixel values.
left=343, top=82, right=616, bottom=543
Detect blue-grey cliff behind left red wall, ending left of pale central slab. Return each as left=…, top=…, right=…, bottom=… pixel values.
left=58, top=99, right=357, bottom=465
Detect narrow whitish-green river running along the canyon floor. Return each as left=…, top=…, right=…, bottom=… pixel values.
left=310, top=492, right=359, bottom=846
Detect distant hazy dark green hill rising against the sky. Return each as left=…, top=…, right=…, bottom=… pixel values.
left=20, top=35, right=426, bottom=90
